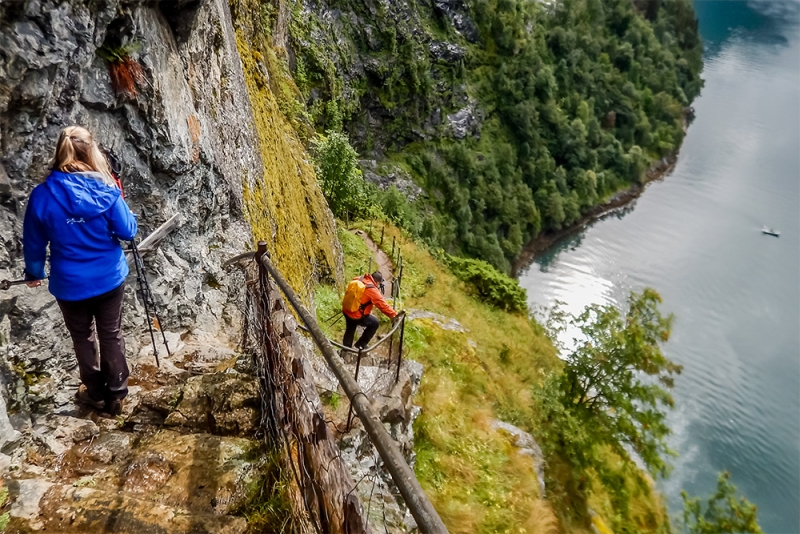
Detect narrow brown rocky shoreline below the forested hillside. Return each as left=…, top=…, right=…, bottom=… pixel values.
left=511, top=150, right=678, bottom=278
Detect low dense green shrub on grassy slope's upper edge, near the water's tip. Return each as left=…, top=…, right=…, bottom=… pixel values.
left=447, top=256, right=528, bottom=313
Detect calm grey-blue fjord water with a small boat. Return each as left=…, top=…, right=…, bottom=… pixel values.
left=519, top=0, right=800, bottom=534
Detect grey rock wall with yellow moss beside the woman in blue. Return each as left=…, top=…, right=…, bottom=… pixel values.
left=0, top=0, right=341, bottom=404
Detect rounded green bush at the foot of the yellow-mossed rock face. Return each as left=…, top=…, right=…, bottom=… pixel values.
left=311, top=131, right=369, bottom=218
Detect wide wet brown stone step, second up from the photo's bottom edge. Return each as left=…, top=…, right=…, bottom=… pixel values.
left=47, top=430, right=262, bottom=515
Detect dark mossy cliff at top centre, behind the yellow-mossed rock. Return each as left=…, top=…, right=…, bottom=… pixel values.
left=289, top=0, right=482, bottom=159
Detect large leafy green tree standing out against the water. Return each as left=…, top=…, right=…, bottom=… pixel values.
left=559, top=289, right=682, bottom=476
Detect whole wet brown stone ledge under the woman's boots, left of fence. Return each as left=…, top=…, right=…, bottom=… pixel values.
left=0, top=344, right=264, bottom=534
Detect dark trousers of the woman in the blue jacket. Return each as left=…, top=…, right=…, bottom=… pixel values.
left=58, top=283, right=128, bottom=401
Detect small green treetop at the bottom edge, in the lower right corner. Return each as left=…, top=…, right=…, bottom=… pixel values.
left=681, top=471, right=763, bottom=534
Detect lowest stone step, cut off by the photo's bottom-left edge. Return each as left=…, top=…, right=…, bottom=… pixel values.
left=6, top=479, right=247, bottom=534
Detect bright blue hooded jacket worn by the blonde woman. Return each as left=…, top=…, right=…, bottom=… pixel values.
left=22, top=171, right=137, bottom=300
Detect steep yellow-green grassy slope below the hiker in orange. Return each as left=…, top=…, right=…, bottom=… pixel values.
left=316, top=223, right=666, bottom=534
